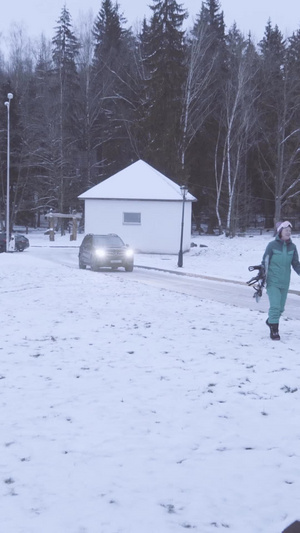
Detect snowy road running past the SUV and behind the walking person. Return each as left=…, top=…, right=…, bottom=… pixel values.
left=30, top=247, right=300, bottom=319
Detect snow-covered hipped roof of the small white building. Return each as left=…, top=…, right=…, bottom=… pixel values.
left=78, top=160, right=196, bottom=201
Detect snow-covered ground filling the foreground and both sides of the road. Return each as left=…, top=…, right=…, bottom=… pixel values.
left=0, top=233, right=300, bottom=533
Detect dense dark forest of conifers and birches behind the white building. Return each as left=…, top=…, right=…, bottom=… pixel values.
left=0, top=0, right=300, bottom=236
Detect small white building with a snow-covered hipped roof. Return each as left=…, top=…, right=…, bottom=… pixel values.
left=79, top=160, right=196, bottom=254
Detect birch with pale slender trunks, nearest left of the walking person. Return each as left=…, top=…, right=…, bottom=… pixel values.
left=215, top=25, right=257, bottom=236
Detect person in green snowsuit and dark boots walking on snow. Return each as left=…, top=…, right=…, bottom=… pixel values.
left=262, top=220, right=300, bottom=340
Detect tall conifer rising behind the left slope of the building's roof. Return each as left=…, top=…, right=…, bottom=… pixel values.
left=92, top=0, right=133, bottom=181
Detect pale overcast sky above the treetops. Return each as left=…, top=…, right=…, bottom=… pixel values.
left=0, top=0, right=300, bottom=42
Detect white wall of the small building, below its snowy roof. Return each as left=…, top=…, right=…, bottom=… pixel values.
left=85, top=199, right=191, bottom=254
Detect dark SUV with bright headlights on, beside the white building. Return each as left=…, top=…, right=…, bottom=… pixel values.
left=78, top=233, right=133, bottom=272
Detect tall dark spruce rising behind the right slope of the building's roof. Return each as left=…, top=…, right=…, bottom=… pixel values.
left=143, top=0, right=187, bottom=180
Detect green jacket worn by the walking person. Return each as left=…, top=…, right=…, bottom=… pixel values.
left=262, top=235, right=300, bottom=289
